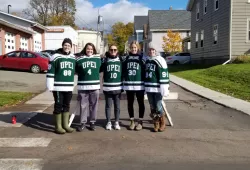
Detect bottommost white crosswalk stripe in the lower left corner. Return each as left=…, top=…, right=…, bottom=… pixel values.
left=0, top=159, right=43, bottom=170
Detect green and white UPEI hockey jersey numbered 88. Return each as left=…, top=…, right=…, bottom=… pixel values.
left=46, top=53, right=75, bottom=91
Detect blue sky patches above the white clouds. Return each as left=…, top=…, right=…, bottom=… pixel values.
left=90, top=0, right=188, bottom=9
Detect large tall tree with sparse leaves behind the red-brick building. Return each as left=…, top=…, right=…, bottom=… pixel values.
left=23, top=0, right=76, bottom=27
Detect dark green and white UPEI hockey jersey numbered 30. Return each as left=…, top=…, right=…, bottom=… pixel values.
left=123, top=54, right=145, bottom=91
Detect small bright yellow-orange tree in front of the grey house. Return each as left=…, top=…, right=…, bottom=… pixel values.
left=162, top=30, right=182, bottom=54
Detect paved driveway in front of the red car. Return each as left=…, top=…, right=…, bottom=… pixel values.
left=0, top=70, right=46, bottom=93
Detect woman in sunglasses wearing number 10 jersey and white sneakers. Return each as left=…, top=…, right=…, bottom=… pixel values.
left=101, top=45, right=122, bottom=130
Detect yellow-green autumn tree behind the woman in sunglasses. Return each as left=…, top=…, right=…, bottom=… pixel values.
left=107, top=22, right=134, bottom=53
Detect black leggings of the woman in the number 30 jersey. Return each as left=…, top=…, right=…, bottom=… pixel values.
left=126, top=90, right=145, bottom=119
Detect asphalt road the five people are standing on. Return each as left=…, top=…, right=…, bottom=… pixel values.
left=0, top=85, right=250, bottom=170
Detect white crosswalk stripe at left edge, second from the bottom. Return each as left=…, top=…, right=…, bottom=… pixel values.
left=0, top=138, right=52, bottom=147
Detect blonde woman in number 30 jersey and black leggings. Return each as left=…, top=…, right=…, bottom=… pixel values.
left=123, top=41, right=145, bottom=131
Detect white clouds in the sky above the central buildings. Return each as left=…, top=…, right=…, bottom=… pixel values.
left=0, top=0, right=149, bottom=30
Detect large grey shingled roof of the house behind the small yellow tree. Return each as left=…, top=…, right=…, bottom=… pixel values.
left=148, top=10, right=191, bottom=30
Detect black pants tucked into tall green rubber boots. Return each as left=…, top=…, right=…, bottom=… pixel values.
left=53, top=91, right=72, bottom=114
